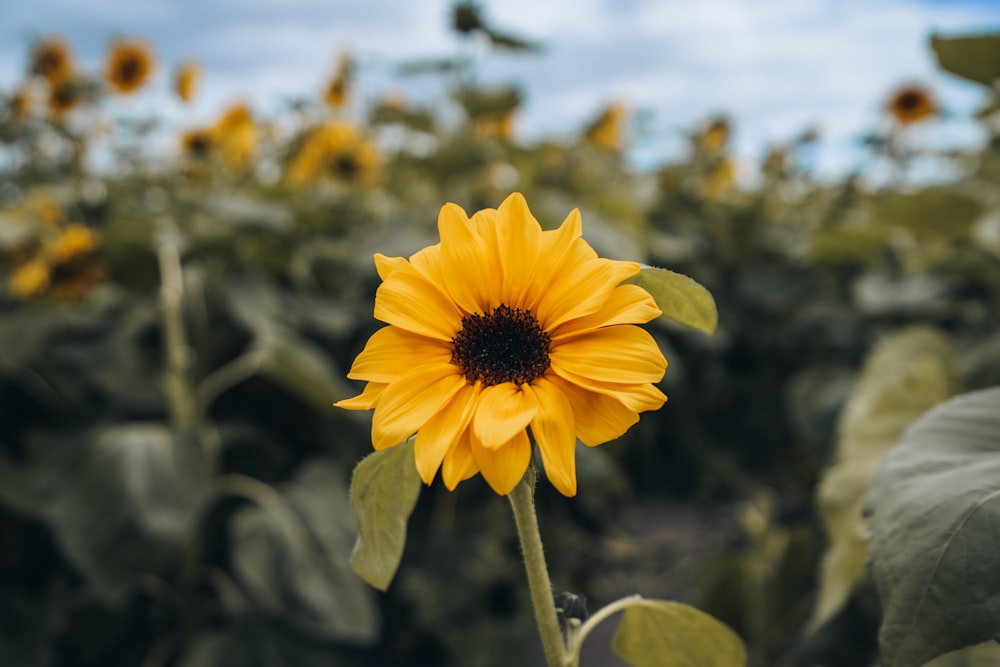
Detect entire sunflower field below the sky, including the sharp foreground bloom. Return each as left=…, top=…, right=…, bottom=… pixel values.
left=0, top=2, right=1000, bottom=667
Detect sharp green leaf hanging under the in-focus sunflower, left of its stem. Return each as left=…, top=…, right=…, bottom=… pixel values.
left=351, top=440, right=421, bottom=591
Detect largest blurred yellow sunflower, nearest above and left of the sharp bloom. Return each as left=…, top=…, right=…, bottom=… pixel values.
left=287, top=122, right=379, bottom=186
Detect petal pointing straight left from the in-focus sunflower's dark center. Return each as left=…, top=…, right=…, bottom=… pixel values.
left=347, top=326, right=451, bottom=382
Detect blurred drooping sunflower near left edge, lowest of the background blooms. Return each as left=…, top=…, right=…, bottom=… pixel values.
left=10, top=225, right=105, bottom=300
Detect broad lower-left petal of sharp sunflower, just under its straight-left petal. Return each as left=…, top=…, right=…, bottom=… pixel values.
left=372, top=364, right=466, bottom=449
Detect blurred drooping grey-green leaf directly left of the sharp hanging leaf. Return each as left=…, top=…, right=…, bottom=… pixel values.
left=230, top=460, right=378, bottom=643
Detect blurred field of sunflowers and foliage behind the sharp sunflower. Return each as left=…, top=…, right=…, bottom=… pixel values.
left=0, top=3, right=1000, bottom=667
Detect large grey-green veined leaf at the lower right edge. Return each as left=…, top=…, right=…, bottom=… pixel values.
left=868, top=387, right=1000, bottom=667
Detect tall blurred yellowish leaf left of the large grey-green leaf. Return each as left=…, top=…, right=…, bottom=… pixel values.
left=810, top=328, right=955, bottom=630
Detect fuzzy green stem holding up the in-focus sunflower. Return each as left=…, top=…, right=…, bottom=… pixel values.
left=507, top=466, right=567, bottom=667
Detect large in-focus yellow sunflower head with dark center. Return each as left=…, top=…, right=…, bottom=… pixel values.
left=336, top=193, right=667, bottom=496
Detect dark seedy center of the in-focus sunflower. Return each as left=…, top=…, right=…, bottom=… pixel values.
left=451, top=305, right=552, bottom=387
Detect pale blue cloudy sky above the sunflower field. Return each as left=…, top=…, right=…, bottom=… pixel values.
left=0, top=0, right=1000, bottom=180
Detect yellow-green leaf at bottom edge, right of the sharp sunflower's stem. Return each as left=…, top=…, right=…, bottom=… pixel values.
left=611, top=598, right=747, bottom=667
